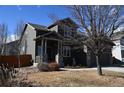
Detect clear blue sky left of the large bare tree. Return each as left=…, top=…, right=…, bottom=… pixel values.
left=0, top=5, right=70, bottom=34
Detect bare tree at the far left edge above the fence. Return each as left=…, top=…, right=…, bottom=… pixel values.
left=0, top=24, right=8, bottom=55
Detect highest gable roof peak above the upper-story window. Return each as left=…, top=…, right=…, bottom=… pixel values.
left=47, top=17, right=78, bottom=29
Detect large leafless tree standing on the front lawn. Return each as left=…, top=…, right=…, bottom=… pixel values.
left=69, top=5, right=123, bottom=75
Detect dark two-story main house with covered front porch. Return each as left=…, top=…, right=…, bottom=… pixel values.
left=6, top=18, right=112, bottom=67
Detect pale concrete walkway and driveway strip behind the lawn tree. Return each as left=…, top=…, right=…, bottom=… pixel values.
left=61, top=67, right=124, bottom=73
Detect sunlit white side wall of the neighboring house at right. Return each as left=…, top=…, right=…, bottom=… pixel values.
left=112, top=40, right=122, bottom=61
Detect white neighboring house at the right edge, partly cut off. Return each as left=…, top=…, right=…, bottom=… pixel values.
left=112, top=27, right=124, bottom=62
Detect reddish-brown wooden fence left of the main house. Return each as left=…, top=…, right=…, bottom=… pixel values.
left=0, top=55, right=33, bottom=67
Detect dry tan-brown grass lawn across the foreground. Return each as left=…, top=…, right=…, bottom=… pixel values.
left=27, top=71, right=124, bottom=87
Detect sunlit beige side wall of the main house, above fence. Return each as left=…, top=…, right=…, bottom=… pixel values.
left=21, top=25, right=36, bottom=61
